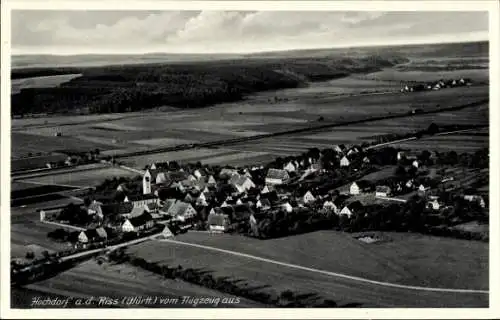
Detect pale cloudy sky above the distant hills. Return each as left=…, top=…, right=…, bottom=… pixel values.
left=11, top=10, right=488, bottom=55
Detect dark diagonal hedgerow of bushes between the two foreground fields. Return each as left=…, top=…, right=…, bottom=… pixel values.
left=109, top=249, right=352, bottom=308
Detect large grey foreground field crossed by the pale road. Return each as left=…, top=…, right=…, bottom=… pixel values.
left=125, top=231, right=488, bottom=307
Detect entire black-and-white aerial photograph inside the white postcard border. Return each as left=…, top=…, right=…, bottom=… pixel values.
left=10, top=8, right=490, bottom=309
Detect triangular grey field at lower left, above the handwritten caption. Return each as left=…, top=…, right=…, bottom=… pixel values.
left=16, top=260, right=265, bottom=308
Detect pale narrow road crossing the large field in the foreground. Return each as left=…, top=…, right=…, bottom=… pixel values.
left=159, top=239, right=489, bottom=295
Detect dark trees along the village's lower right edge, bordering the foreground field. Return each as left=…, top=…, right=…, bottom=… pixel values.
left=250, top=192, right=488, bottom=239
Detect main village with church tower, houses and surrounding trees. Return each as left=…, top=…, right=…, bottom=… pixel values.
left=28, top=140, right=488, bottom=255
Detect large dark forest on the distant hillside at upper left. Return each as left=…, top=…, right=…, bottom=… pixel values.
left=11, top=57, right=404, bottom=116
